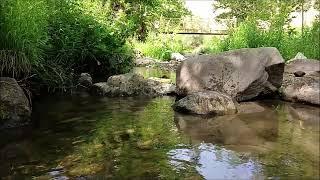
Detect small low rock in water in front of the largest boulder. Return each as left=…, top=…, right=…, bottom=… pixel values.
left=173, top=91, right=237, bottom=115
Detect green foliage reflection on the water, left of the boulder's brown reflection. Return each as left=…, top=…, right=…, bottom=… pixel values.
left=55, top=97, right=195, bottom=178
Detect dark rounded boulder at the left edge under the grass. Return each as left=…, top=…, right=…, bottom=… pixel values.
left=0, top=77, right=31, bottom=127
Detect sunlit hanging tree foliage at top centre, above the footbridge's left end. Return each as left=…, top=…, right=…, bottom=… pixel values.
left=105, top=0, right=188, bottom=41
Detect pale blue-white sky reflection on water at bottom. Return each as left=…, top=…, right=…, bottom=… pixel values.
left=168, top=143, right=262, bottom=179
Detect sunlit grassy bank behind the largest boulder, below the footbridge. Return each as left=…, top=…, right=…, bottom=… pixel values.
left=133, top=21, right=320, bottom=60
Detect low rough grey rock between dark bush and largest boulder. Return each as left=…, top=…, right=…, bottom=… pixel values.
left=92, top=73, right=175, bottom=97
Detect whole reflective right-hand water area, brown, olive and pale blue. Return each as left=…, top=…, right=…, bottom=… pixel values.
left=174, top=102, right=320, bottom=179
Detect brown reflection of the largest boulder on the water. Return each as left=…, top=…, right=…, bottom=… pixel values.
left=175, top=111, right=278, bottom=150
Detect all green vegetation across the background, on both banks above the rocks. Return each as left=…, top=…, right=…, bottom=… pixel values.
left=0, top=0, right=320, bottom=91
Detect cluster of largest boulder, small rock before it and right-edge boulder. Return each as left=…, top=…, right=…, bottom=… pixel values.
left=173, top=48, right=320, bottom=115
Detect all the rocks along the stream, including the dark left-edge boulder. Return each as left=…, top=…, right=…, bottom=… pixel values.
left=0, top=48, right=320, bottom=128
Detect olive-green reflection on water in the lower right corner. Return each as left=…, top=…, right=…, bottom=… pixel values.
left=259, top=104, right=320, bottom=178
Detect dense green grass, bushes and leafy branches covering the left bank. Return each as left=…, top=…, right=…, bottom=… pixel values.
left=0, top=0, right=187, bottom=90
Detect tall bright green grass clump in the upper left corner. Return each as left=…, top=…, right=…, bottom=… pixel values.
left=0, top=0, right=48, bottom=77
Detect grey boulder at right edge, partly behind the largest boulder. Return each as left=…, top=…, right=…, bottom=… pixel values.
left=280, top=59, right=320, bottom=105
